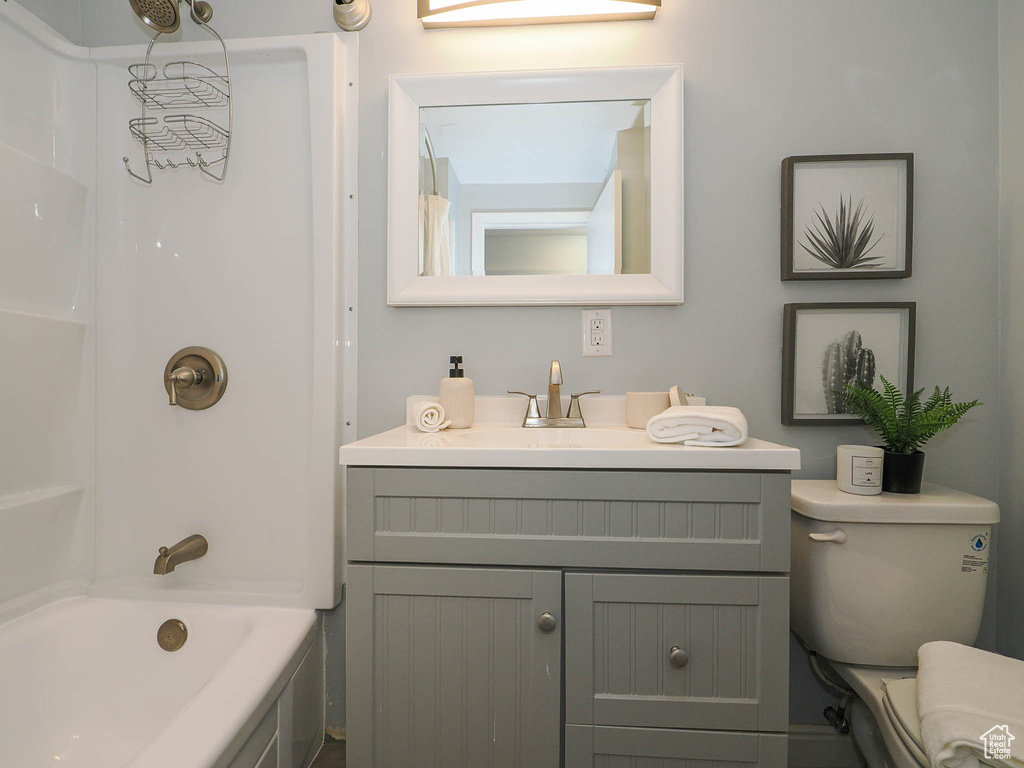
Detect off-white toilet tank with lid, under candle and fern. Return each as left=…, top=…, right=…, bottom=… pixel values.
left=790, top=480, right=999, bottom=667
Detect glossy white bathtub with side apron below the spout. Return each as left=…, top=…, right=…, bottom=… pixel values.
left=0, top=597, right=323, bottom=768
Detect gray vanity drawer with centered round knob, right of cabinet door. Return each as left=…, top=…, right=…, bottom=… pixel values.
left=564, top=573, right=790, bottom=732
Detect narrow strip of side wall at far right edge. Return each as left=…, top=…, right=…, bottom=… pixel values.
left=997, top=0, right=1024, bottom=658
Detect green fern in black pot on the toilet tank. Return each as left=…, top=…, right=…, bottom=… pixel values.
left=836, top=376, right=983, bottom=494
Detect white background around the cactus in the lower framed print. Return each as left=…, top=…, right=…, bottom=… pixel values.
left=793, top=308, right=910, bottom=419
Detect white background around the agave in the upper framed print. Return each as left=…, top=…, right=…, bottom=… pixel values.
left=793, top=159, right=907, bottom=273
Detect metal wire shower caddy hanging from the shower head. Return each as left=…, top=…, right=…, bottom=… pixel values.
left=122, top=0, right=233, bottom=184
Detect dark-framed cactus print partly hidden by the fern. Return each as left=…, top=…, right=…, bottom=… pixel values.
left=782, top=301, right=918, bottom=427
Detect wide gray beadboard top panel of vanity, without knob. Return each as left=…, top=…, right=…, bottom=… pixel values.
left=347, top=467, right=790, bottom=572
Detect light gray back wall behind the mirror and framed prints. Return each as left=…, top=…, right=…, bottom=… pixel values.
left=74, top=0, right=1007, bottom=722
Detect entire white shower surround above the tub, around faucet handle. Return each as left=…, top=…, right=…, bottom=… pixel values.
left=0, top=3, right=356, bottom=616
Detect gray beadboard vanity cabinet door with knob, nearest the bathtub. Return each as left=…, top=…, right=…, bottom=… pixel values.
left=346, top=565, right=562, bottom=768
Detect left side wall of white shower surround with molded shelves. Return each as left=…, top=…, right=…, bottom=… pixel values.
left=0, top=3, right=95, bottom=621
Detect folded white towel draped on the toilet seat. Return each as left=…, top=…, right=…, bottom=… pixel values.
left=918, top=641, right=1024, bottom=768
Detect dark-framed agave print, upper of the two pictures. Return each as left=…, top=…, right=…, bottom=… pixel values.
left=782, top=154, right=913, bottom=281
